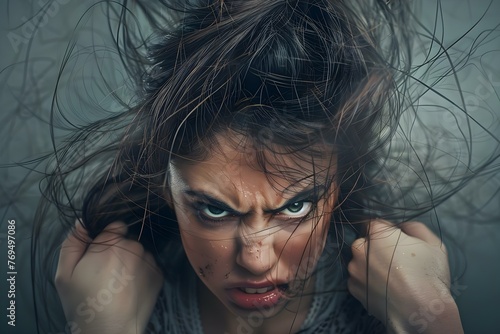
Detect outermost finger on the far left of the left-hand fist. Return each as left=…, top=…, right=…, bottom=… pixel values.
left=56, top=220, right=92, bottom=279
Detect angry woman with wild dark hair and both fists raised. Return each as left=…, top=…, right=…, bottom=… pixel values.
left=11, top=0, right=496, bottom=333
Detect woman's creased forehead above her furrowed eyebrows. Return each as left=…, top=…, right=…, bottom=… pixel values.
left=170, top=134, right=336, bottom=193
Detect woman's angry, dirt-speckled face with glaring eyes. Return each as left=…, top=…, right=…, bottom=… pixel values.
left=170, top=138, right=336, bottom=317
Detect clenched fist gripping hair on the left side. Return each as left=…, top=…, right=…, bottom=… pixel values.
left=55, top=222, right=163, bottom=334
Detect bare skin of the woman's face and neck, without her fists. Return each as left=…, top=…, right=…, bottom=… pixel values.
left=170, top=138, right=336, bottom=334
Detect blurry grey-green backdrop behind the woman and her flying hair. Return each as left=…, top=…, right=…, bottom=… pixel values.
left=0, top=0, right=500, bottom=334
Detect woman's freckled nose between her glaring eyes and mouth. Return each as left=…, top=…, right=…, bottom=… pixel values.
left=236, top=224, right=278, bottom=276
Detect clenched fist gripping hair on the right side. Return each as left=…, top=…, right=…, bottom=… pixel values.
left=348, top=220, right=463, bottom=333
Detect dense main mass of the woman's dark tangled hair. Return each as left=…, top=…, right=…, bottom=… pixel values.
left=47, top=1, right=411, bottom=240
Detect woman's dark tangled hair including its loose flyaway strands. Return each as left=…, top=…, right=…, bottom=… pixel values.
left=2, top=0, right=494, bottom=332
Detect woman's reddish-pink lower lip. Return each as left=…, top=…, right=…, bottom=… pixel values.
left=227, top=287, right=284, bottom=310
